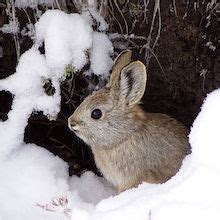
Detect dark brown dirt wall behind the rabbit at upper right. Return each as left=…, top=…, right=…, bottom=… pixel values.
left=144, top=0, right=220, bottom=127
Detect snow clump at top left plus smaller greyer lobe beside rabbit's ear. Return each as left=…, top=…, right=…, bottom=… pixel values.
left=35, top=10, right=113, bottom=79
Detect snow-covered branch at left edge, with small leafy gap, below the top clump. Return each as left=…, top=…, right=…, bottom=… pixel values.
left=0, top=48, right=61, bottom=158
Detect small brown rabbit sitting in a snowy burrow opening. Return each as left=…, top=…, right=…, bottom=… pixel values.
left=68, top=50, right=190, bottom=192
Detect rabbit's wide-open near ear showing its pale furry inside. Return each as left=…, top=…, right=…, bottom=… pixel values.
left=118, top=61, right=147, bottom=105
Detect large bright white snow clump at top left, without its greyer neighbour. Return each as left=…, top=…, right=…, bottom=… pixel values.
left=35, top=10, right=92, bottom=74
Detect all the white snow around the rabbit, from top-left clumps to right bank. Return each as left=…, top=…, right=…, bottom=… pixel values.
left=0, top=11, right=220, bottom=220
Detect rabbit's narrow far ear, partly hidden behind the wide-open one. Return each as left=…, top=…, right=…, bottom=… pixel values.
left=109, top=50, right=132, bottom=85
